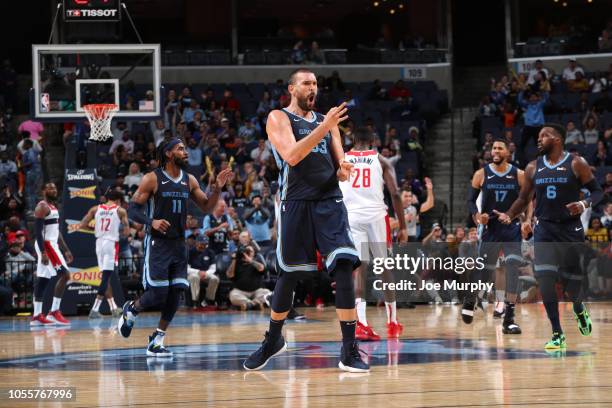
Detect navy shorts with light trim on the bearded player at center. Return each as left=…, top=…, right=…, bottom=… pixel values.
left=276, top=198, right=360, bottom=272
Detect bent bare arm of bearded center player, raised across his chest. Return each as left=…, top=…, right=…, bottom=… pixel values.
left=266, top=102, right=348, bottom=166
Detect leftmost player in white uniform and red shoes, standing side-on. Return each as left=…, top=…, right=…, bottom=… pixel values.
left=30, top=183, right=73, bottom=326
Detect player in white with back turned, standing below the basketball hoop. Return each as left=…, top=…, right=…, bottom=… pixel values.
left=71, top=190, right=130, bottom=319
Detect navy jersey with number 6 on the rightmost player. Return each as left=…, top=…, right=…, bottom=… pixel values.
left=533, top=152, right=581, bottom=222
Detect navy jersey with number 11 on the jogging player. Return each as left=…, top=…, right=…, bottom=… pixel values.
left=147, top=168, right=190, bottom=240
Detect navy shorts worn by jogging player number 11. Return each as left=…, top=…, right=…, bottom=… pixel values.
left=142, top=235, right=189, bottom=289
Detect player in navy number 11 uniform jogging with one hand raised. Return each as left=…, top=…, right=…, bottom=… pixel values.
left=117, top=138, right=233, bottom=357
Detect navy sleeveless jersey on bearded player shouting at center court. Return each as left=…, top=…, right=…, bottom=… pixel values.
left=272, top=109, right=342, bottom=201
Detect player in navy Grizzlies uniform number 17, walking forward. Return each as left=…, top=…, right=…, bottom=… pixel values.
left=461, top=139, right=531, bottom=334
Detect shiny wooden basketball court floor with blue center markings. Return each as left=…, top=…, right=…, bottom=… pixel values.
left=0, top=303, right=612, bottom=407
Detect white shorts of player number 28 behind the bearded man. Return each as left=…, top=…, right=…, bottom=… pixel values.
left=349, top=214, right=390, bottom=261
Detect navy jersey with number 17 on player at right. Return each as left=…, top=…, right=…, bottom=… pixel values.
left=480, top=164, right=520, bottom=215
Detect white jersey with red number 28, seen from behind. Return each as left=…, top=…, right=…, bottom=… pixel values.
left=339, top=150, right=387, bottom=223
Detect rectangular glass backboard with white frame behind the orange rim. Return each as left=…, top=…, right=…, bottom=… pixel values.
left=30, top=44, right=162, bottom=120
